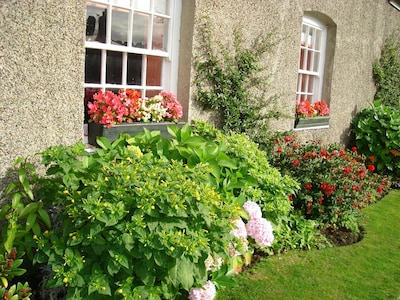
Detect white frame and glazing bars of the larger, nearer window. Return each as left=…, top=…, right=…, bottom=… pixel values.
left=84, top=0, right=182, bottom=96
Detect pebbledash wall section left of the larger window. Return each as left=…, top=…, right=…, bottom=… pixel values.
left=0, top=0, right=86, bottom=190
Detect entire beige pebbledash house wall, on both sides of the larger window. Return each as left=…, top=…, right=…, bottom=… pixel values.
left=0, top=0, right=400, bottom=191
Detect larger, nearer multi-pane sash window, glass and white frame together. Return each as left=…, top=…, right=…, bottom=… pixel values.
left=84, top=0, right=181, bottom=97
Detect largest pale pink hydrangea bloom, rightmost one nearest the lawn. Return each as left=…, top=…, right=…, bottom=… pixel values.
left=246, top=218, right=274, bottom=247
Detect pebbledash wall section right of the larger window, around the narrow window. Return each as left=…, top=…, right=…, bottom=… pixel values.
left=185, top=0, right=400, bottom=142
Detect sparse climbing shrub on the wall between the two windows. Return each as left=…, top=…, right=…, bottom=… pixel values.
left=195, top=21, right=278, bottom=139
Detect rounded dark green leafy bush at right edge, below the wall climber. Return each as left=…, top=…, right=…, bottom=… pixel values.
left=351, top=102, right=400, bottom=177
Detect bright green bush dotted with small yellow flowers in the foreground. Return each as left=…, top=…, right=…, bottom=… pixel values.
left=35, top=138, right=241, bottom=299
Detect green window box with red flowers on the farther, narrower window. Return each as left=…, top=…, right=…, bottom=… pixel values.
left=295, top=99, right=330, bottom=128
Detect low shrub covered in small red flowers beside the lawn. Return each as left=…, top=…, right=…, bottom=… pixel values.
left=267, top=133, right=390, bottom=229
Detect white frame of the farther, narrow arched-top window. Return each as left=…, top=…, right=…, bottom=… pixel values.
left=296, top=15, right=328, bottom=102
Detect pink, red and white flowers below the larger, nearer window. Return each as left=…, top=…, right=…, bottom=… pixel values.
left=87, top=89, right=182, bottom=127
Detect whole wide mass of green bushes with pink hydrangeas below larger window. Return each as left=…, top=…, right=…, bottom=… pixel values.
left=3, top=124, right=297, bottom=299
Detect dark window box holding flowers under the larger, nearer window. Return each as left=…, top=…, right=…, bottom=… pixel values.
left=88, top=122, right=185, bottom=146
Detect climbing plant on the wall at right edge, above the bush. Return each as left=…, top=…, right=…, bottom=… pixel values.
left=373, top=35, right=400, bottom=110
